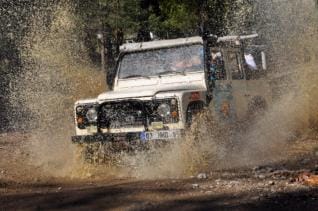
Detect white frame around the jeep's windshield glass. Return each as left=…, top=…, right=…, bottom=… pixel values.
left=116, top=42, right=205, bottom=81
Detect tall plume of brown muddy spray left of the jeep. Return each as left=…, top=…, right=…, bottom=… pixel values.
left=11, top=3, right=106, bottom=176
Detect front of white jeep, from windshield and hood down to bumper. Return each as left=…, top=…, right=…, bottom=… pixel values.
left=72, top=37, right=209, bottom=143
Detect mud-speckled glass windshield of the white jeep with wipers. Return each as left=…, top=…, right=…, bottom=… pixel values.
left=119, top=44, right=204, bottom=79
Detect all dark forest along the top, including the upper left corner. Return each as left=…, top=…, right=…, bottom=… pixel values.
left=0, top=0, right=253, bottom=72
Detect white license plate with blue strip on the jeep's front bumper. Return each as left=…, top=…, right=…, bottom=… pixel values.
left=140, top=130, right=180, bottom=141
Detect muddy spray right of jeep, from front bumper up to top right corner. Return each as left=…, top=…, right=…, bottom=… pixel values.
left=120, top=0, right=318, bottom=178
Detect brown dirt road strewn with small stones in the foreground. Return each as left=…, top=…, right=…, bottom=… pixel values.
left=0, top=134, right=318, bottom=210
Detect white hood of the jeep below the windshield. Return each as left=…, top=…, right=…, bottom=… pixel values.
left=98, top=74, right=207, bottom=101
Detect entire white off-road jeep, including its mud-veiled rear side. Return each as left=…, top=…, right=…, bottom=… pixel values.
left=72, top=34, right=271, bottom=156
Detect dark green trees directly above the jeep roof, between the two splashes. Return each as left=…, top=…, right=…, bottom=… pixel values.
left=74, top=0, right=253, bottom=62
